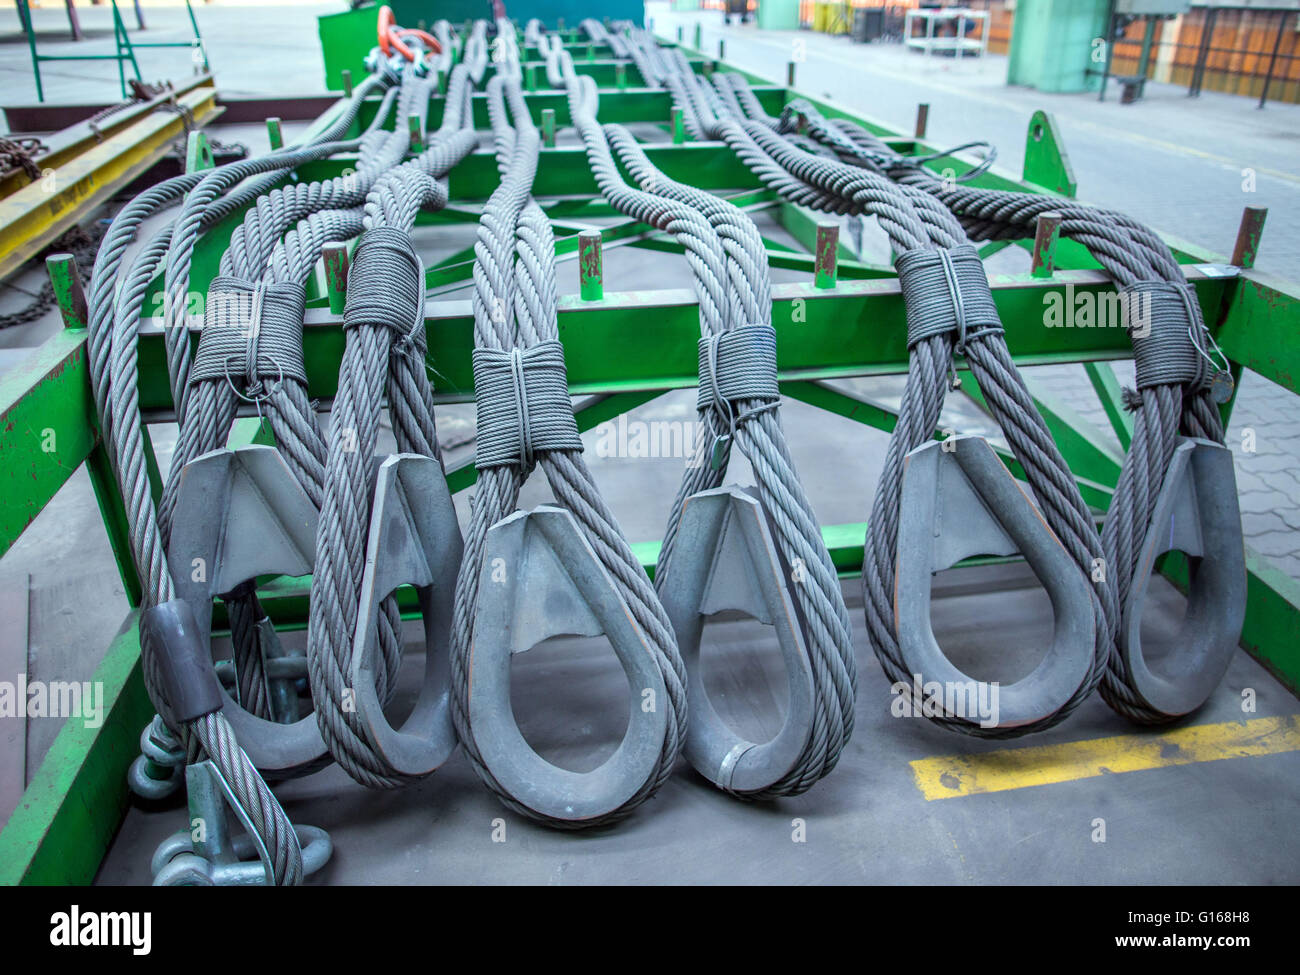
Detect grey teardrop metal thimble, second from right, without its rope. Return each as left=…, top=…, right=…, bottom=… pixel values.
left=894, top=436, right=1097, bottom=728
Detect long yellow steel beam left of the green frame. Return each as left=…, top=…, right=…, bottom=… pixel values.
left=0, top=87, right=222, bottom=280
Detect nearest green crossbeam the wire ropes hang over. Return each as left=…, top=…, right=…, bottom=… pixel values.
left=119, top=269, right=1226, bottom=410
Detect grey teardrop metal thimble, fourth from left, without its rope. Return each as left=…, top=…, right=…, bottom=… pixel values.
left=659, top=486, right=815, bottom=793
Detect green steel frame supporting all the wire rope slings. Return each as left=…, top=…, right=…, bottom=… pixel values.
left=0, top=40, right=1300, bottom=883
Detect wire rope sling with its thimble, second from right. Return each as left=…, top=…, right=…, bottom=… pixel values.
left=650, top=45, right=1117, bottom=737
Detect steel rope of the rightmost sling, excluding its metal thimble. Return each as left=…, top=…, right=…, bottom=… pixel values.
left=811, top=110, right=1223, bottom=724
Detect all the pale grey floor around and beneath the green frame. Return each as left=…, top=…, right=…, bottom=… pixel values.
left=0, top=4, right=1300, bottom=883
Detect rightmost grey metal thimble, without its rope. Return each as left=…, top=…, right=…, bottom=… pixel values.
left=1119, top=437, right=1245, bottom=715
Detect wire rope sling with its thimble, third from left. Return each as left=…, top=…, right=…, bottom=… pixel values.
left=451, top=22, right=686, bottom=828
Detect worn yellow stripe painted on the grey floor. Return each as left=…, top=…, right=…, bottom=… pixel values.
left=911, top=715, right=1300, bottom=800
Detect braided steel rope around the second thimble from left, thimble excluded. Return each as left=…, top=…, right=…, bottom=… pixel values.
left=308, top=63, right=477, bottom=788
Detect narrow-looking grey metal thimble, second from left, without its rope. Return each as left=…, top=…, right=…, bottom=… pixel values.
left=348, top=454, right=463, bottom=776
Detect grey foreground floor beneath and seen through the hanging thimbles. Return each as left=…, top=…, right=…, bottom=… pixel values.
left=99, top=569, right=1300, bottom=885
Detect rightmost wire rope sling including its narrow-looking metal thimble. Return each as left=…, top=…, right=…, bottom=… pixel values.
left=811, top=105, right=1245, bottom=724
